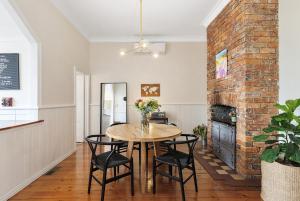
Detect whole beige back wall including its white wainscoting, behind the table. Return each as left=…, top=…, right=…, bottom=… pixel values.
left=90, top=42, right=207, bottom=133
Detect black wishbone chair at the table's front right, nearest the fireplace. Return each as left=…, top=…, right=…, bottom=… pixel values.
left=153, top=134, right=198, bottom=201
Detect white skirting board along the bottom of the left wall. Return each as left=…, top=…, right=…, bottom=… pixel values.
left=0, top=148, right=76, bottom=201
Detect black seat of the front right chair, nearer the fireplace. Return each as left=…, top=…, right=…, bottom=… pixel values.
left=156, top=150, right=189, bottom=168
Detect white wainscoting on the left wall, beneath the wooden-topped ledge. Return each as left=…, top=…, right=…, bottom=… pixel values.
left=0, top=106, right=75, bottom=201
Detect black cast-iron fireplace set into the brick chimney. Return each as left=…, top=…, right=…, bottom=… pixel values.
left=211, top=105, right=236, bottom=169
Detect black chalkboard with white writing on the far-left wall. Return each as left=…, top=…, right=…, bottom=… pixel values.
left=0, top=53, right=20, bottom=90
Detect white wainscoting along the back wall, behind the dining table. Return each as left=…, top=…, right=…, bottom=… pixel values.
left=90, top=104, right=207, bottom=134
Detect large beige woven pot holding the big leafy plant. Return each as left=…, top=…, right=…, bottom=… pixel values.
left=261, top=161, right=300, bottom=201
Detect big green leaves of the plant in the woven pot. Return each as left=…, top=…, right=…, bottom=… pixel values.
left=253, top=99, right=300, bottom=166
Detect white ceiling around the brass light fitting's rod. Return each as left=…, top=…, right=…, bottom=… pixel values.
left=52, top=0, right=228, bottom=42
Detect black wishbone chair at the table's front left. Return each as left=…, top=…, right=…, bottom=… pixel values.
left=85, top=135, right=134, bottom=201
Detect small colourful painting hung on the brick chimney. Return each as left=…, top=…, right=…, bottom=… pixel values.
left=216, top=49, right=228, bottom=79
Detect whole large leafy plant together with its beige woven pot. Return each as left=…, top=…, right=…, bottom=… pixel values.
left=254, top=99, right=300, bottom=201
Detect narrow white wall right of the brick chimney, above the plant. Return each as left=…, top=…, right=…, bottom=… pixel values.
left=279, top=0, right=300, bottom=102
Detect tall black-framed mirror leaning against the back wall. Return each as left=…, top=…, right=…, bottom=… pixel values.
left=100, top=82, right=127, bottom=134
